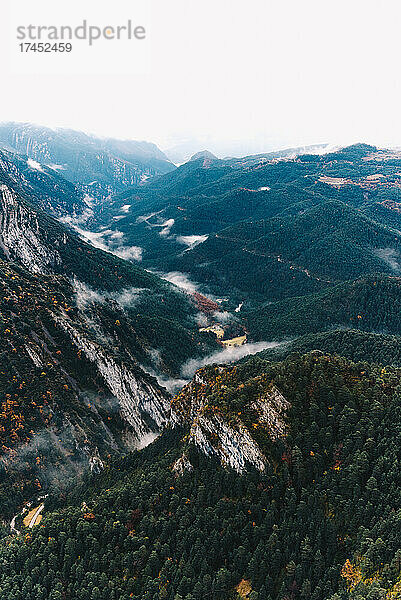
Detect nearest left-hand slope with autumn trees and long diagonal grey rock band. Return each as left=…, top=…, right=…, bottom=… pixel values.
left=0, top=261, right=169, bottom=514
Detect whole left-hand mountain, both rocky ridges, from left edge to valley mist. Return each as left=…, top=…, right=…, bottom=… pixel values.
left=0, top=163, right=219, bottom=514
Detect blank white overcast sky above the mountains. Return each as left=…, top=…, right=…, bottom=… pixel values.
left=0, top=0, right=401, bottom=153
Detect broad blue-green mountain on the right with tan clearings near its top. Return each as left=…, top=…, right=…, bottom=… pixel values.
left=87, top=144, right=401, bottom=298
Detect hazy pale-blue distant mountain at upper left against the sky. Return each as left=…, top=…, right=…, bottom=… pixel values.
left=0, top=123, right=174, bottom=200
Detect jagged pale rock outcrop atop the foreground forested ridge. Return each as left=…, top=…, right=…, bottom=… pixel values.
left=172, top=367, right=290, bottom=473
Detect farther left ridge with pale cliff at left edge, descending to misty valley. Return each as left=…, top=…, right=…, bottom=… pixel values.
left=0, top=170, right=219, bottom=372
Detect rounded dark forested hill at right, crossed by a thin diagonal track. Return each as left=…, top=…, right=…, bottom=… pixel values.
left=168, top=201, right=401, bottom=300
